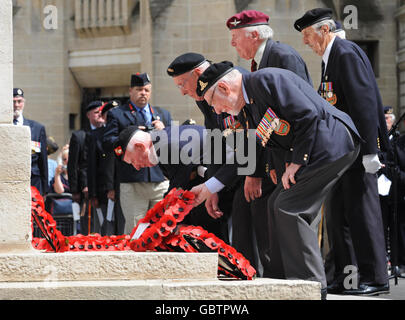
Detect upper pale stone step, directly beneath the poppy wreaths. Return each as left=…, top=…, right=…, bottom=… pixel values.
left=0, top=251, right=218, bottom=283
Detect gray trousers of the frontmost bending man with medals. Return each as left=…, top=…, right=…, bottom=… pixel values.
left=268, top=145, right=360, bottom=288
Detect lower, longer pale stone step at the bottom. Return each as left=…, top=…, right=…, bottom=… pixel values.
left=0, top=278, right=320, bottom=300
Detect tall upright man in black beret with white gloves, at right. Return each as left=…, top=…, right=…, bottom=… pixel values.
left=294, top=8, right=389, bottom=295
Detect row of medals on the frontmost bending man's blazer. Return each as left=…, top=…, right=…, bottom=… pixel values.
left=256, top=108, right=291, bottom=147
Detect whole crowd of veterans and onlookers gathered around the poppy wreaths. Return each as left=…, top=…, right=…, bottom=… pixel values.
left=14, top=8, right=405, bottom=297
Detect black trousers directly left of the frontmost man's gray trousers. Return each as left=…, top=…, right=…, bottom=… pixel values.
left=232, top=178, right=276, bottom=277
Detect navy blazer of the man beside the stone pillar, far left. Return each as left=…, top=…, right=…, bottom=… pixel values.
left=23, top=118, right=48, bottom=195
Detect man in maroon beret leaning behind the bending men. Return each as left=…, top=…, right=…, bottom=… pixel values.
left=226, top=10, right=312, bottom=272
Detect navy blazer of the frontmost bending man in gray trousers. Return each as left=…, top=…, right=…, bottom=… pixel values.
left=239, top=68, right=360, bottom=167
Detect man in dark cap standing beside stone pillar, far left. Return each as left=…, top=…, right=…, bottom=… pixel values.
left=13, top=88, right=48, bottom=196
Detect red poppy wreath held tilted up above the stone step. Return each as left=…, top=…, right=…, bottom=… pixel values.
left=130, top=188, right=194, bottom=252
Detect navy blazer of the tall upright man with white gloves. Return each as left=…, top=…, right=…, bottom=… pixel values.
left=319, top=37, right=389, bottom=159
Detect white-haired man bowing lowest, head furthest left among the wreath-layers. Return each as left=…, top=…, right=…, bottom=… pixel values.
left=115, top=125, right=227, bottom=239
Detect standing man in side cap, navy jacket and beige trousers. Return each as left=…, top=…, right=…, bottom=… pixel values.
left=103, top=73, right=171, bottom=234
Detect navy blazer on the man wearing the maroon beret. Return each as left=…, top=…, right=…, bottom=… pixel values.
left=258, top=39, right=312, bottom=86
